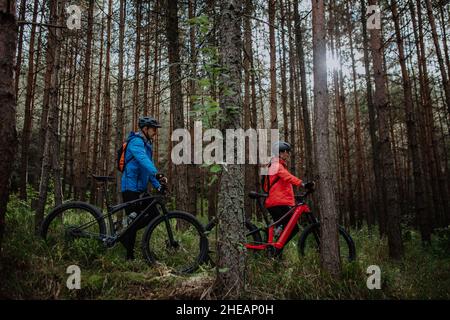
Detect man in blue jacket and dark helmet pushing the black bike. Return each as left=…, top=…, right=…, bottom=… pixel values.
left=122, top=117, right=167, bottom=260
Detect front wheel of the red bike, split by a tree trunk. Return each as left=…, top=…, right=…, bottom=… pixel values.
left=298, top=222, right=356, bottom=261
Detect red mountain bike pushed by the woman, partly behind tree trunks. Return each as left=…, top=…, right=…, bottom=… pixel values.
left=205, top=190, right=356, bottom=263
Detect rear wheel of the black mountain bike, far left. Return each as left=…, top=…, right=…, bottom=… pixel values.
left=40, top=201, right=106, bottom=262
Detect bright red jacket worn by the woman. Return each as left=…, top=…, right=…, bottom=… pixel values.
left=264, top=157, right=302, bottom=208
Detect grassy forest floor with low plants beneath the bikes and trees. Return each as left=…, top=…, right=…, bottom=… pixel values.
left=0, top=195, right=450, bottom=299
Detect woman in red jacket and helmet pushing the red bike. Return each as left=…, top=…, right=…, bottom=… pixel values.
left=264, top=141, right=314, bottom=254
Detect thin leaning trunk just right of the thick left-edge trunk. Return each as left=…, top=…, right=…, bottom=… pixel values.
left=19, top=0, right=39, bottom=201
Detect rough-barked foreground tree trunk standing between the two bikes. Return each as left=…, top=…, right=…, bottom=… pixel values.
left=215, top=0, right=245, bottom=299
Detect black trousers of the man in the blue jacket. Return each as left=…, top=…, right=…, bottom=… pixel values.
left=121, top=191, right=158, bottom=260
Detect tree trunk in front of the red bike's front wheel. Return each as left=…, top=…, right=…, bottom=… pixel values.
left=312, top=0, right=341, bottom=275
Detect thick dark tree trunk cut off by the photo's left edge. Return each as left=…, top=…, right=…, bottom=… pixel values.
left=0, top=0, right=17, bottom=250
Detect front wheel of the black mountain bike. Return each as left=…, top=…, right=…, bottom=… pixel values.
left=142, top=211, right=208, bottom=273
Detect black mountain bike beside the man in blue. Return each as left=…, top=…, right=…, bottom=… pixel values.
left=41, top=175, right=208, bottom=273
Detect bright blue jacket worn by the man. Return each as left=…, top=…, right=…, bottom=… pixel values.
left=122, top=132, right=160, bottom=192
